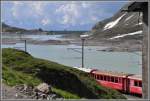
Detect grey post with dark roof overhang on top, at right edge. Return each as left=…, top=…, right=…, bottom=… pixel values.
left=125, top=2, right=150, bottom=99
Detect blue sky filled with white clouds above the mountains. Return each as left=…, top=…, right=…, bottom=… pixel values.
left=2, top=1, right=126, bottom=28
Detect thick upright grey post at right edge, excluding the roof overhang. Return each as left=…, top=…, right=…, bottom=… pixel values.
left=142, top=3, right=149, bottom=99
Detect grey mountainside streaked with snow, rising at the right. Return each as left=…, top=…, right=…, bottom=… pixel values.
left=91, top=4, right=143, bottom=50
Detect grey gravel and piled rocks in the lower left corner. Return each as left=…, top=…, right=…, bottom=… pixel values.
left=2, top=83, right=62, bottom=100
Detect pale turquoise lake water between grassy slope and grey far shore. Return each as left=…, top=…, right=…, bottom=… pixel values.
left=2, top=43, right=142, bottom=74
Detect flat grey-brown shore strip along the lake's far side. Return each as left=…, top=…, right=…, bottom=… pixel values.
left=2, top=38, right=142, bottom=52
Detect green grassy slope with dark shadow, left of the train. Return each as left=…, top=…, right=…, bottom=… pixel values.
left=2, top=48, right=125, bottom=98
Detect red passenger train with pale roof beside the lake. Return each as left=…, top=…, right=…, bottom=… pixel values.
left=73, top=68, right=142, bottom=96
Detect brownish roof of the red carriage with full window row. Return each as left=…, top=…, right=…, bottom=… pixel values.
left=92, top=70, right=133, bottom=77
